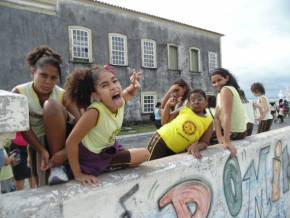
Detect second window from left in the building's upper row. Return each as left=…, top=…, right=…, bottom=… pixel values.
left=109, top=33, right=128, bottom=66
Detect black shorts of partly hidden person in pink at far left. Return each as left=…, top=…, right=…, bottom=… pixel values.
left=10, top=143, right=31, bottom=181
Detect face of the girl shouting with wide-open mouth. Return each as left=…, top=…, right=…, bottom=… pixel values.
left=94, top=71, right=124, bottom=113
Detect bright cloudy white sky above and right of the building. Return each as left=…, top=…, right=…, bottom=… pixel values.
left=101, top=0, right=290, bottom=97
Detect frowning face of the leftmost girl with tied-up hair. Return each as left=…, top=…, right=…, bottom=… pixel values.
left=32, top=64, right=59, bottom=95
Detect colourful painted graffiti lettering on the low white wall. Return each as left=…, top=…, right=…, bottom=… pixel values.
left=114, top=141, right=290, bottom=218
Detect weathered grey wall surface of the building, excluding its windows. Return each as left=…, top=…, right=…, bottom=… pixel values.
left=0, top=0, right=221, bottom=121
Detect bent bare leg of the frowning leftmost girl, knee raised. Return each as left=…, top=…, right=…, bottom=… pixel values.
left=43, top=100, right=68, bottom=166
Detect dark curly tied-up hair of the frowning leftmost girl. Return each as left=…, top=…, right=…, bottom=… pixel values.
left=26, top=45, right=62, bottom=80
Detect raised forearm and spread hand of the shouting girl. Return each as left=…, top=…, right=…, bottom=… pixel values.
left=122, top=70, right=142, bottom=101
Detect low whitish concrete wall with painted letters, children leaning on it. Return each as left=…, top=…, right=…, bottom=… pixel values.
left=0, top=127, right=290, bottom=218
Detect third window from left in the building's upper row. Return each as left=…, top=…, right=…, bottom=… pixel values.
left=141, top=39, right=157, bottom=68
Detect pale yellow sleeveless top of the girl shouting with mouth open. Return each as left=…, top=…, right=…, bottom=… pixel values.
left=82, top=102, right=125, bottom=153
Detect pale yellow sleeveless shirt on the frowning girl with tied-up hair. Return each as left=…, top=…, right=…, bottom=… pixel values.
left=15, top=82, right=64, bottom=138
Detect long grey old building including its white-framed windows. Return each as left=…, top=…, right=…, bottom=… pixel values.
left=0, top=0, right=223, bottom=121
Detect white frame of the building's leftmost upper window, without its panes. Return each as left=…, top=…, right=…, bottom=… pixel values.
left=68, top=26, right=93, bottom=63
